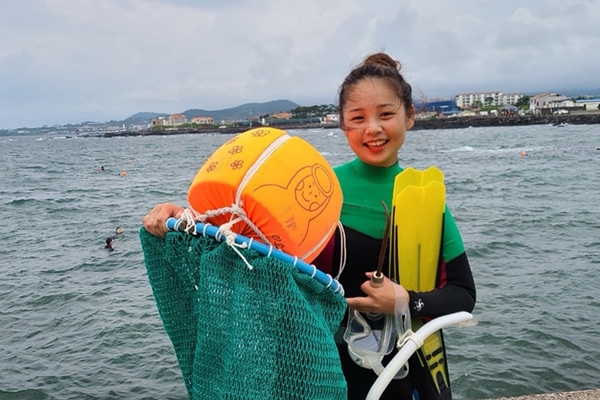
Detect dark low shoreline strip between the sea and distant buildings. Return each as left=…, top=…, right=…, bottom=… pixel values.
left=95, top=112, right=600, bottom=138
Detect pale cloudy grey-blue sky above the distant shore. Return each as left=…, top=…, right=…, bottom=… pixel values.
left=0, top=0, right=600, bottom=129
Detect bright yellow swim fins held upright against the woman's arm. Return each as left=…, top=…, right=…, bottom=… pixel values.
left=389, top=167, right=450, bottom=394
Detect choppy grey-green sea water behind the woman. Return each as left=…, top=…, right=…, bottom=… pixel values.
left=0, top=125, right=600, bottom=399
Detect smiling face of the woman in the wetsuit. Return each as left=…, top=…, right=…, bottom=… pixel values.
left=342, top=78, right=415, bottom=167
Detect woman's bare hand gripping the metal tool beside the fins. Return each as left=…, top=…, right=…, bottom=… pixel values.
left=346, top=272, right=409, bottom=314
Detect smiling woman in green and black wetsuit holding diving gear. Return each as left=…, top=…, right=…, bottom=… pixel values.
left=143, top=53, right=476, bottom=400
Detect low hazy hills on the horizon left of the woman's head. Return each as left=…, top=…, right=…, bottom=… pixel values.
left=123, top=100, right=300, bottom=125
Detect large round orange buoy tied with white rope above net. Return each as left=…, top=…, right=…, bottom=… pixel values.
left=188, top=127, right=342, bottom=263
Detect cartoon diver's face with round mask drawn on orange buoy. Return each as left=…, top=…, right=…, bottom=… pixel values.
left=295, top=164, right=333, bottom=212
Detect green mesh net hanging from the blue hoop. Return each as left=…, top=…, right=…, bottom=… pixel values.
left=140, top=228, right=347, bottom=400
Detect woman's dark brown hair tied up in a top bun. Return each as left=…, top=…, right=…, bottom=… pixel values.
left=338, top=53, right=413, bottom=128
